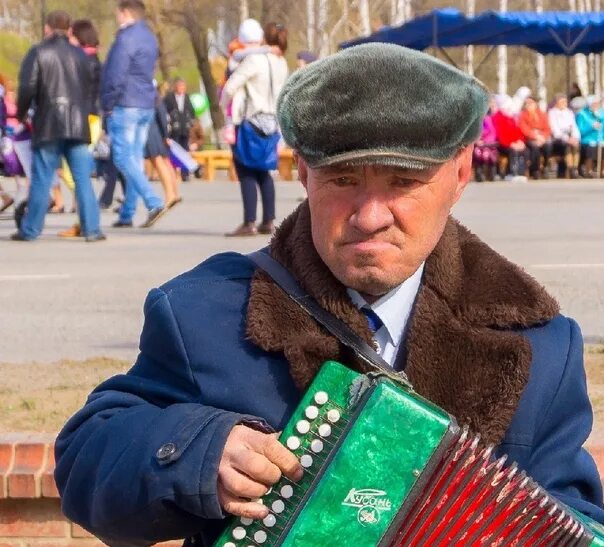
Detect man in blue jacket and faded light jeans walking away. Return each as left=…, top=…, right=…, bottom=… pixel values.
left=101, top=0, right=166, bottom=228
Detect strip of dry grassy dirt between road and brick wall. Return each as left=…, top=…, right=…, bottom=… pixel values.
left=0, top=352, right=604, bottom=443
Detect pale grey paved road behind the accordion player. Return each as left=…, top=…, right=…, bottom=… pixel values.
left=0, top=181, right=604, bottom=362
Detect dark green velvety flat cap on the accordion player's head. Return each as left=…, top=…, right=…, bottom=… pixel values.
left=277, top=43, right=489, bottom=169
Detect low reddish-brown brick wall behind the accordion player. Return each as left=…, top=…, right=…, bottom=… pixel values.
left=0, top=434, right=604, bottom=547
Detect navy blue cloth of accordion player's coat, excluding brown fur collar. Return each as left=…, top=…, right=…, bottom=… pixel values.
left=55, top=253, right=604, bottom=546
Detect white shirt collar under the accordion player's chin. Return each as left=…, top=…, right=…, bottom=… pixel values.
left=346, top=262, right=425, bottom=346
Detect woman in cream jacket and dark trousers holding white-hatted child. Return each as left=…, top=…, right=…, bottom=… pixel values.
left=221, top=19, right=288, bottom=237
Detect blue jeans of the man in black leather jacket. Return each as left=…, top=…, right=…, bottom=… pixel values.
left=20, top=140, right=101, bottom=239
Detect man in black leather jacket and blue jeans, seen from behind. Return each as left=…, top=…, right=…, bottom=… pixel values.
left=11, top=11, right=105, bottom=242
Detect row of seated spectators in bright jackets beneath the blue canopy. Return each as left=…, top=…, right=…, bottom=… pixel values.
left=474, top=84, right=604, bottom=182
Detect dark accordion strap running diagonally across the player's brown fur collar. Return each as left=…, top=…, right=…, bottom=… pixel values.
left=247, top=248, right=412, bottom=389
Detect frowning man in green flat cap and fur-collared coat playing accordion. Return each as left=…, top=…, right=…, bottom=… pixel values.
left=55, top=44, right=604, bottom=546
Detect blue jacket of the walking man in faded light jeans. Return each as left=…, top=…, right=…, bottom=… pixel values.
left=101, top=21, right=159, bottom=113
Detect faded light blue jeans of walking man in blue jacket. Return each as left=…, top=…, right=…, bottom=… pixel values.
left=107, top=106, right=164, bottom=222
